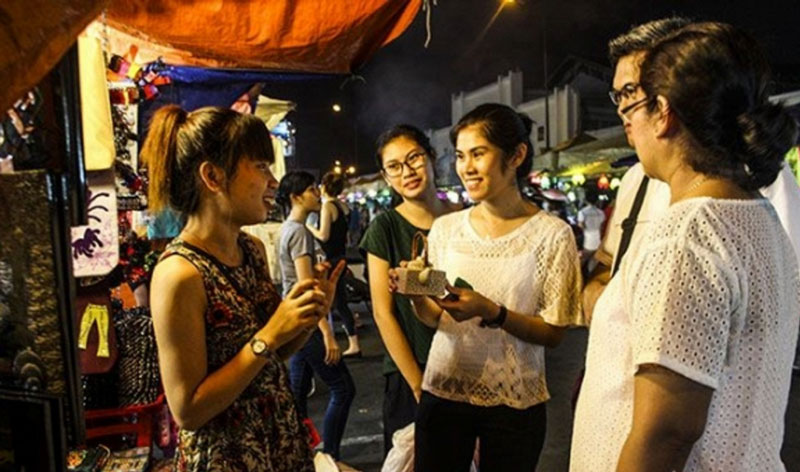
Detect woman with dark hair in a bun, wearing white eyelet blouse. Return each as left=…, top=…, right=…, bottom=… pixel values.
left=570, top=23, right=800, bottom=472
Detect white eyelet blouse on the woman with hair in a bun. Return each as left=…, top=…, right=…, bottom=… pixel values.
left=570, top=198, right=800, bottom=472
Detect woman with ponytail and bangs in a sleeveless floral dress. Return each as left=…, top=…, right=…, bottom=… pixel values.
left=142, top=106, right=341, bottom=472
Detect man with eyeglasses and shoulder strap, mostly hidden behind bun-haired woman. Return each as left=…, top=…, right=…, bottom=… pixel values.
left=583, top=17, right=800, bottom=373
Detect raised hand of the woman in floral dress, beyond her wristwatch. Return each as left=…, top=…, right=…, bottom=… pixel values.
left=259, top=279, right=327, bottom=350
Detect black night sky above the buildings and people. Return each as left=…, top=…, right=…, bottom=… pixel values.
left=265, top=0, right=800, bottom=173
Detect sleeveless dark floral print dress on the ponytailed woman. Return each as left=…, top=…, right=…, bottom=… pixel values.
left=161, top=233, right=314, bottom=472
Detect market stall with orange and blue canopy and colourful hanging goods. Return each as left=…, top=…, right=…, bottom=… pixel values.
left=0, top=0, right=421, bottom=470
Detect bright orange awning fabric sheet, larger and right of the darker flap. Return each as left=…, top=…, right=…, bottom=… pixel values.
left=108, top=0, right=422, bottom=73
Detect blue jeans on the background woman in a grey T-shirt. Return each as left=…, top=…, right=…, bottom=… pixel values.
left=289, top=329, right=356, bottom=460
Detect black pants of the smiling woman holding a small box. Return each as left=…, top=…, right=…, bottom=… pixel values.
left=414, top=392, right=547, bottom=472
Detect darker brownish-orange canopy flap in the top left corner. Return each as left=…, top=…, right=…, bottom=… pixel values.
left=0, top=0, right=108, bottom=111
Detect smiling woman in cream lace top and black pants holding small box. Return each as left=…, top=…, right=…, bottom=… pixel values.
left=396, top=104, right=582, bottom=472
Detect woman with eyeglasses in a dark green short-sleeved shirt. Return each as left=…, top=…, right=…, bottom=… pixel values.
left=361, top=125, right=456, bottom=453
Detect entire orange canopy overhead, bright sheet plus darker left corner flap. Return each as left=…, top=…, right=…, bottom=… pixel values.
left=0, top=0, right=422, bottom=110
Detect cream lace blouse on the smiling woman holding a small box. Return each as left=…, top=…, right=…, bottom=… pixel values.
left=422, top=209, right=584, bottom=409
